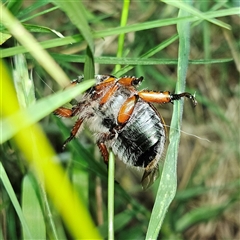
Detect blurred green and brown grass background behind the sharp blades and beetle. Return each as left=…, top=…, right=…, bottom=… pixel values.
left=0, top=0, right=240, bottom=239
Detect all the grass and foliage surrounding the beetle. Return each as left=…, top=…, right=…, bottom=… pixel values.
left=0, top=1, right=240, bottom=239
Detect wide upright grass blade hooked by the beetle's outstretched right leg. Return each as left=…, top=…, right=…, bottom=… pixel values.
left=146, top=1, right=191, bottom=239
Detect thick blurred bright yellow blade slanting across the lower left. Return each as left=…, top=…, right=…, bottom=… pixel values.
left=0, top=60, right=101, bottom=239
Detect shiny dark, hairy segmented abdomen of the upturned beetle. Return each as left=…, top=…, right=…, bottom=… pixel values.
left=111, top=100, right=166, bottom=167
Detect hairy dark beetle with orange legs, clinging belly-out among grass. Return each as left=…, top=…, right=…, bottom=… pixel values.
left=54, top=75, right=197, bottom=189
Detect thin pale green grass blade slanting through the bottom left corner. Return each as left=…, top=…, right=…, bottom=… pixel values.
left=0, top=162, right=33, bottom=239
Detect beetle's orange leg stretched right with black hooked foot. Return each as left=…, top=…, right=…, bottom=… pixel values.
left=138, top=90, right=197, bottom=106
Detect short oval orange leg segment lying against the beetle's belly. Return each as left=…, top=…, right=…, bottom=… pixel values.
left=117, top=95, right=139, bottom=125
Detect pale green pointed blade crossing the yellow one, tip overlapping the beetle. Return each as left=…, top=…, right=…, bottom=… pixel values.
left=0, top=80, right=95, bottom=143
